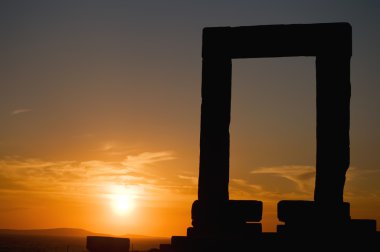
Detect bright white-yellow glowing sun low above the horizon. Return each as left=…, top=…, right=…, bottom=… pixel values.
left=109, top=186, right=136, bottom=216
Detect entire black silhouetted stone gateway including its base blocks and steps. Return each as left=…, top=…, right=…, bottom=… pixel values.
left=87, top=23, right=380, bottom=252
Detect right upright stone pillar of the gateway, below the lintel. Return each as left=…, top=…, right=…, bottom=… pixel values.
left=314, top=55, right=351, bottom=207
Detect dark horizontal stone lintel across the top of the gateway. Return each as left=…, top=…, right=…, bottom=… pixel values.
left=202, top=23, right=352, bottom=59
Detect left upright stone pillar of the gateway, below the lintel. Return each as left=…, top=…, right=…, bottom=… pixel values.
left=198, top=57, right=232, bottom=204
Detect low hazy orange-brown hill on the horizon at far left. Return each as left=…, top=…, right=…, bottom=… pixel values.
left=0, top=228, right=110, bottom=237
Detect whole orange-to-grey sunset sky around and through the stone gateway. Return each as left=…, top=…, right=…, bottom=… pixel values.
left=0, top=0, right=380, bottom=236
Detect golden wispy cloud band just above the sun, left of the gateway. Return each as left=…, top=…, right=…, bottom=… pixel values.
left=0, top=151, right=175, bottom=202
